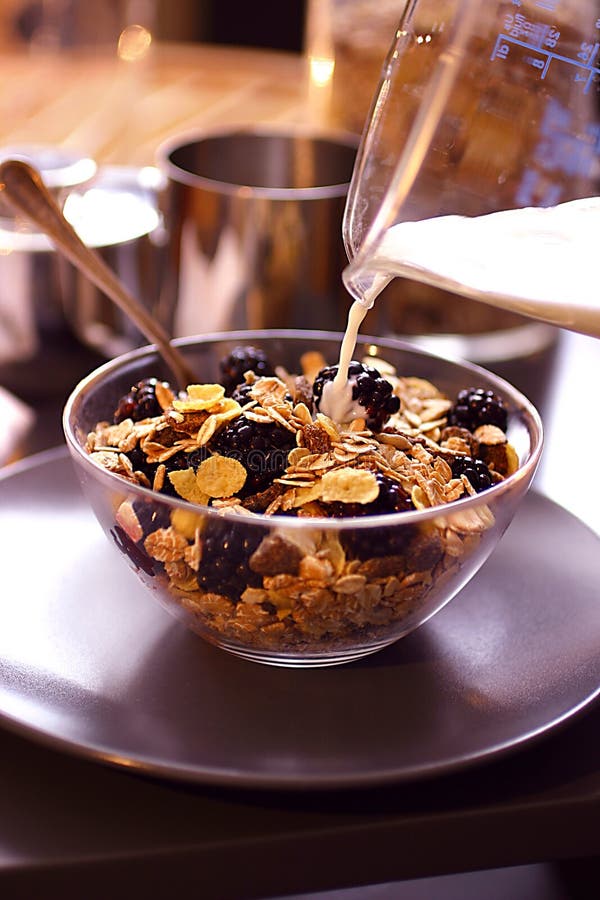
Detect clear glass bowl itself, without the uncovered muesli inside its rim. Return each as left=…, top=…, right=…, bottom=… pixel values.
left=63, top=331, right=543, bottom=667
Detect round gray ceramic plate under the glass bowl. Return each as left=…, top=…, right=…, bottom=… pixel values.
left=0, top=450, right=600, bottom=788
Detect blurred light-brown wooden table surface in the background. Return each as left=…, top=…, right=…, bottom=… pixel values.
left=0, top=43, right=326, bottom=166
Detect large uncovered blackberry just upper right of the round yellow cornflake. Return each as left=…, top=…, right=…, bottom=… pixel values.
left=210, top=413, right=296, bottom=497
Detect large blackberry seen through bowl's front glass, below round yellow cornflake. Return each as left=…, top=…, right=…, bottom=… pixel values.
left=198, top=518, right=263, bottom=603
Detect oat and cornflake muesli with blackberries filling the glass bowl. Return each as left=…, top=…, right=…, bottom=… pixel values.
left=86, top=353, right=518, bottom=652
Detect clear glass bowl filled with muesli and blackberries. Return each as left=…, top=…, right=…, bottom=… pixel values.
left=64, top=331, right=543, bottom=667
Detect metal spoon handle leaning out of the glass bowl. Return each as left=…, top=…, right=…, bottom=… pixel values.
left=0, top=159, right=196, bottom=388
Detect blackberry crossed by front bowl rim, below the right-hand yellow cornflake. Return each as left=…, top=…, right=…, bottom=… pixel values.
left=326, top=472, right=414, bottom=559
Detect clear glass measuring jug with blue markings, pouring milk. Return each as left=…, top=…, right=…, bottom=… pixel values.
left=343, top=0, right=600, bottom=336
